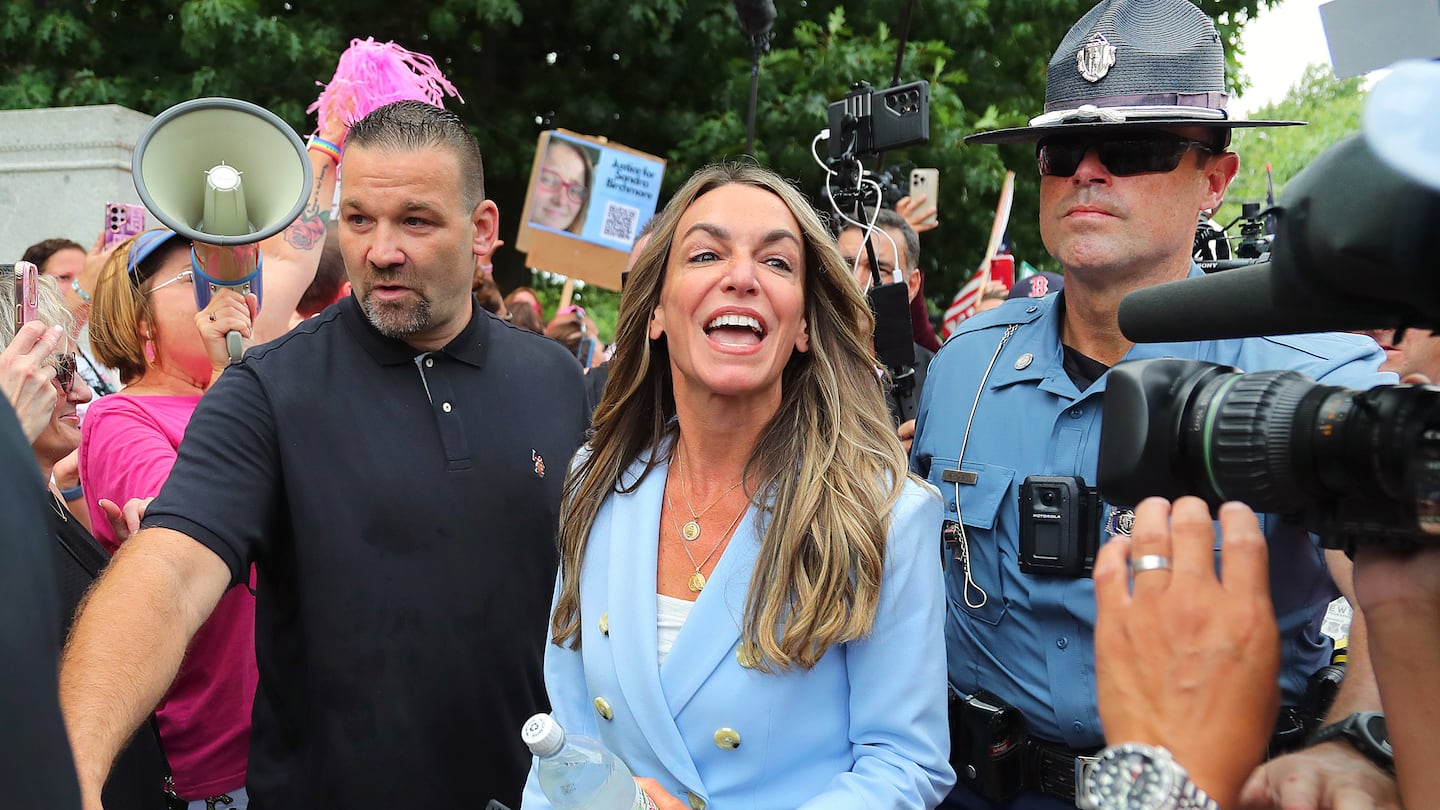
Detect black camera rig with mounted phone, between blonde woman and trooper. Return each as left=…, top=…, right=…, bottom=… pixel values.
left=816, top=81, right=930, bottom=423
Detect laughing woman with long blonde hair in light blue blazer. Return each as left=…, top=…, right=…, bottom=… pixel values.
left=524, top=164, right=953, bottom=810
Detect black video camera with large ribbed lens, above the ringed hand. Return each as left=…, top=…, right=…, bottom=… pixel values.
left=1099, top=357, right=1440, bottom=548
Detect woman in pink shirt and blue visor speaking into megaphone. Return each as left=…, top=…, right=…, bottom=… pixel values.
left=81, top=231, right=256, bottom=810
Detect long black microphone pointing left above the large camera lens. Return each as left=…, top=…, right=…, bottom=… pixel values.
left=1119, top=264, right=1401, bottom=343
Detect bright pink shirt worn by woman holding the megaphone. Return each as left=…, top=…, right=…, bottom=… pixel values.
left=81, top=393, right=258, bottom=800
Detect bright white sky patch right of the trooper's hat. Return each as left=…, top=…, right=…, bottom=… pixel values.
left=1231, top=0, right=1331, bottom=114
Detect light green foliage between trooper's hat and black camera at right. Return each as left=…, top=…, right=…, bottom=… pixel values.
left=1215, top=65, right=1365, bottom=223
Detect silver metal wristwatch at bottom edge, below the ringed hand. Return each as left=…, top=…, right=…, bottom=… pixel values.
left=1076, top=742, right=1220, bottom=810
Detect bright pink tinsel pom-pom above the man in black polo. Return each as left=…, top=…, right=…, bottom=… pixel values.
left=305, top=37, right=465, bottom=135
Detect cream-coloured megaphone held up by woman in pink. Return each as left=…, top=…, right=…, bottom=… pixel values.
left=131, top=98, right=312, bottom=360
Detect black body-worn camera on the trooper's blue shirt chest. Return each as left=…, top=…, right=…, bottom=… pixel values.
left=1020, top=476, right=1100, bottom=577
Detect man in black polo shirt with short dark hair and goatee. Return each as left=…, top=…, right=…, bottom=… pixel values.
left=60, top=102, right=588, bottom=810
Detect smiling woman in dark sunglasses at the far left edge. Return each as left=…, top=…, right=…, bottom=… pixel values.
left=0, top=271, right=166, bottom=810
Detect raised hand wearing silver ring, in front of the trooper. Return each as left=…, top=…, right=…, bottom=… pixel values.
left=1094, top=497, right=1280, bottom=807
